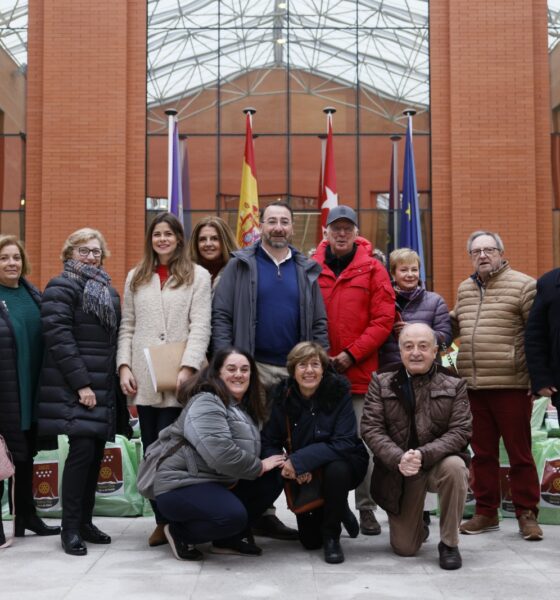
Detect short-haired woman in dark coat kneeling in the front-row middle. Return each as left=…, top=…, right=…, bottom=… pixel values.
left=261, top=342, right=368, bottom=563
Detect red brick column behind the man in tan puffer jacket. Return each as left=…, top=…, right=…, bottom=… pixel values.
left=430, top=0, right=552, bottom=304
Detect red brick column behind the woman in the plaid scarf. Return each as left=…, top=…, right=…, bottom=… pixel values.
left=26, top=0, right=146, bottom=289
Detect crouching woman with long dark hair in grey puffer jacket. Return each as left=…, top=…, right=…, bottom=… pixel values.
left=154, top=348, right=285, bottom=560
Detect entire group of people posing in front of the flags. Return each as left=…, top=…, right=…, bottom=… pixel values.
left=0, top=202, right=560, bottom=569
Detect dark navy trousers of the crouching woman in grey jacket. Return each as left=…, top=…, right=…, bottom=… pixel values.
left=156, top=469, right=283, bottom=544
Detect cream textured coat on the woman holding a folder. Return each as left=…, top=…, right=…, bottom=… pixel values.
left=117, top=265, right=212, bottom=408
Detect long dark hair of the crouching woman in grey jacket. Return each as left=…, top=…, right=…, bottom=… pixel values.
left=177, top=346, right=267, bottom=423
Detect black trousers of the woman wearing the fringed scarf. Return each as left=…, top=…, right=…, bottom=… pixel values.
left=62, top=436, right=105, bottom=529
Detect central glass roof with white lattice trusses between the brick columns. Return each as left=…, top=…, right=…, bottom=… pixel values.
left=147, top=0, right=429, bottom=118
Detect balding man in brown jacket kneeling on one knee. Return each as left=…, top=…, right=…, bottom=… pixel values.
left=361, top=323, right=472, bottom=570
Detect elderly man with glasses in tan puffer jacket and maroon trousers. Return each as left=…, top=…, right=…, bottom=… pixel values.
left=451, top=231, right=543, bottom=541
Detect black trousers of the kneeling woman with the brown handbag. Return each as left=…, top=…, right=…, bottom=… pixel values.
left=296, top=460, right=364, bottom=550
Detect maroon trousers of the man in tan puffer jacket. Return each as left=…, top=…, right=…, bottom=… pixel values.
left=469, top=390, right=540, bottom=517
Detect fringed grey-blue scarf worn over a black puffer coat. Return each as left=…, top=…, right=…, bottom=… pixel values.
left=62, top=258, right=117, bottom=332
